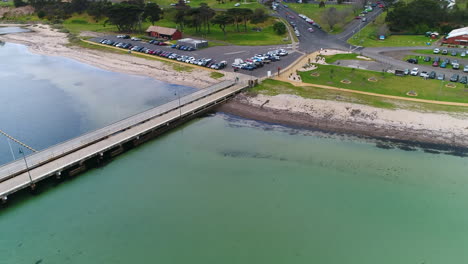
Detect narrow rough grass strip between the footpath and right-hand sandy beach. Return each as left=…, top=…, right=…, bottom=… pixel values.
left=247, top=79, right=468, bottom=112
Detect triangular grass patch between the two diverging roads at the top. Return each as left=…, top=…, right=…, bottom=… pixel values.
left=288, top=3, right=354, bottom=34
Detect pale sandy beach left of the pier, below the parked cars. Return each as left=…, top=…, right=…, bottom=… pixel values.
left=0, top=24, right=234, bottom=88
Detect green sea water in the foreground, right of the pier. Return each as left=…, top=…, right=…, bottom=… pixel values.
left=0, top=114, right=468, bottom=264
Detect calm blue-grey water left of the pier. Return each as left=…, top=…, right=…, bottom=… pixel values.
left=0, top=41, right=196, bottom=165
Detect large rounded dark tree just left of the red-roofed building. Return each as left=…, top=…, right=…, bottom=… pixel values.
left=104, top=3, right=143, bottom=32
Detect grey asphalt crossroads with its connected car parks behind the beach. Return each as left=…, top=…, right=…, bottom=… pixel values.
left=91, top=5, right=465, bottom=81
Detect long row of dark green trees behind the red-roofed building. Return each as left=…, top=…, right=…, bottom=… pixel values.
left=14, top=0, right=268, bottom=37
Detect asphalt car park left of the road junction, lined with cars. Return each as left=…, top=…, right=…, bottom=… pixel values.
left=90, top=35, right=300, bottom=77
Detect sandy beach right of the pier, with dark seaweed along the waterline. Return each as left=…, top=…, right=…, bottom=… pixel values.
left=219, top=94, right=468, bottom=148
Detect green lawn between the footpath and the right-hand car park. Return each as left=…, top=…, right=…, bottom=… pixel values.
left=300, top=65, right=468, bottom=103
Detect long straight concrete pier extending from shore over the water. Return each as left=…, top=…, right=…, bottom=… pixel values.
left=0, top=81, right=247, bottom=202
